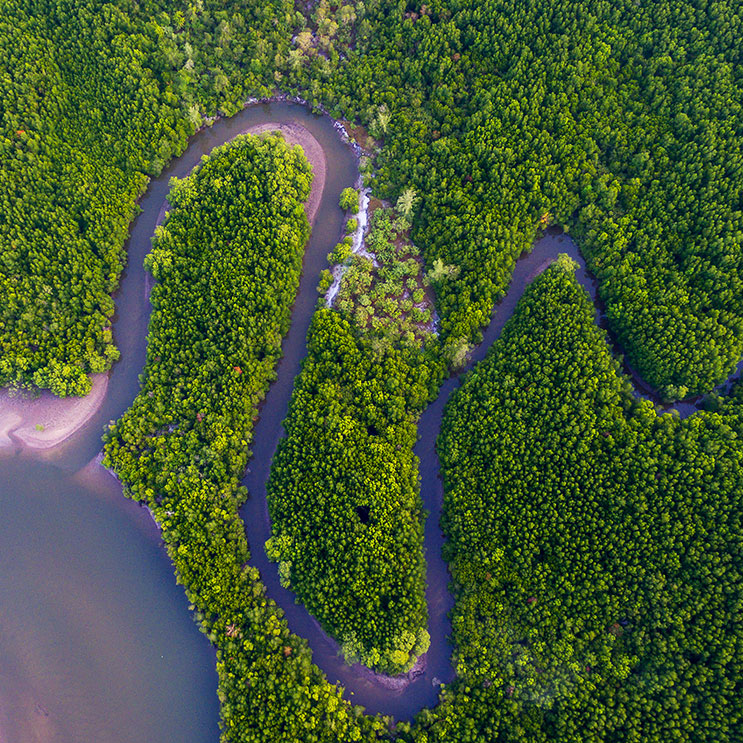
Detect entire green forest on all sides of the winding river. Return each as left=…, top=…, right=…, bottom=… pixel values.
left=8, top=0, right=743, bottom=743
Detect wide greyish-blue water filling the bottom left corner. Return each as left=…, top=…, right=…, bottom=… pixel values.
left=0, top=458, right=219, bottom=743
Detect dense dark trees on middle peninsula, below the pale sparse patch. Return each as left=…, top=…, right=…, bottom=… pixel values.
left=267, top=310, right=430, bottom=673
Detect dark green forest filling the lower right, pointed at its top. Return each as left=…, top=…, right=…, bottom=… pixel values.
left=430, top=257, right=743, bottom=742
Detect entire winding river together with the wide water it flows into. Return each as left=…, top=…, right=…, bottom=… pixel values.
left=0, top=103, right=732, bottom=743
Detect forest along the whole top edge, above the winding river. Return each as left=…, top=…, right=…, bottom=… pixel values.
left=5, top=0, right=743, bottom=397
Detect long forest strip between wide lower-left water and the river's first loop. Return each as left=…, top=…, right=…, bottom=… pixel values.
left=105, top=136, right=378, bottom=743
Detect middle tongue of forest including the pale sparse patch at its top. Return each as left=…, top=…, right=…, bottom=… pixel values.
left=267, top=198, right=438, bottom=674
